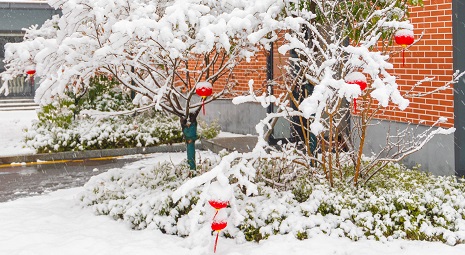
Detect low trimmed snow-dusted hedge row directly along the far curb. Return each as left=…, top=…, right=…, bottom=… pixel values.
left=24, top=114, right=182, bottom=153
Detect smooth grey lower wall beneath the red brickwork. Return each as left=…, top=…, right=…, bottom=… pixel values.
left=205, top=99, right=455, bottom=175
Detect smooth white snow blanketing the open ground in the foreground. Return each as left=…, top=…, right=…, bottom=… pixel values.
left=0, top=182, right=465, bottom=255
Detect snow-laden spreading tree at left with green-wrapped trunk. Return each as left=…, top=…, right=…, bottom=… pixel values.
left=0, top=0, right=280, bottom=169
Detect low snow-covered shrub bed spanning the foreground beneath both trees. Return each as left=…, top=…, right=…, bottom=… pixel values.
left=81, top=155, right=465, bottom=245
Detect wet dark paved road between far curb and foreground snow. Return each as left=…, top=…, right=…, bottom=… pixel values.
left=0, top=158, right=138, bottom=202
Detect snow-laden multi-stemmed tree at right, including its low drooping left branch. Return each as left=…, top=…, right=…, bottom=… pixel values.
left=174, top=0, right=460, bottom=207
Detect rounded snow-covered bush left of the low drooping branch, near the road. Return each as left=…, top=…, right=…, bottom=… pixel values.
left=81, top=157, right=203, bottom=233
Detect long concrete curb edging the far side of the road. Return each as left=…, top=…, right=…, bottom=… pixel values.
left=0, top=142, right=204, bottom=164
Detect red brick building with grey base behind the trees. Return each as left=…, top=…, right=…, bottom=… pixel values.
left=207, top=0, right=465, bottom=176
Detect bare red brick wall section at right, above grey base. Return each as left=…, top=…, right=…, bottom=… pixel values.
left=379, top=0, right=454, bottom=127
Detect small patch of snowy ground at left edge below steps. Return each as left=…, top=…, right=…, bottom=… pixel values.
left=0, top=111, right=37, bottom=156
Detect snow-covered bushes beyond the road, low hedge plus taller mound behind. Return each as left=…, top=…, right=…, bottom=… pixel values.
left=24, top=76, right=186, bottom=153
